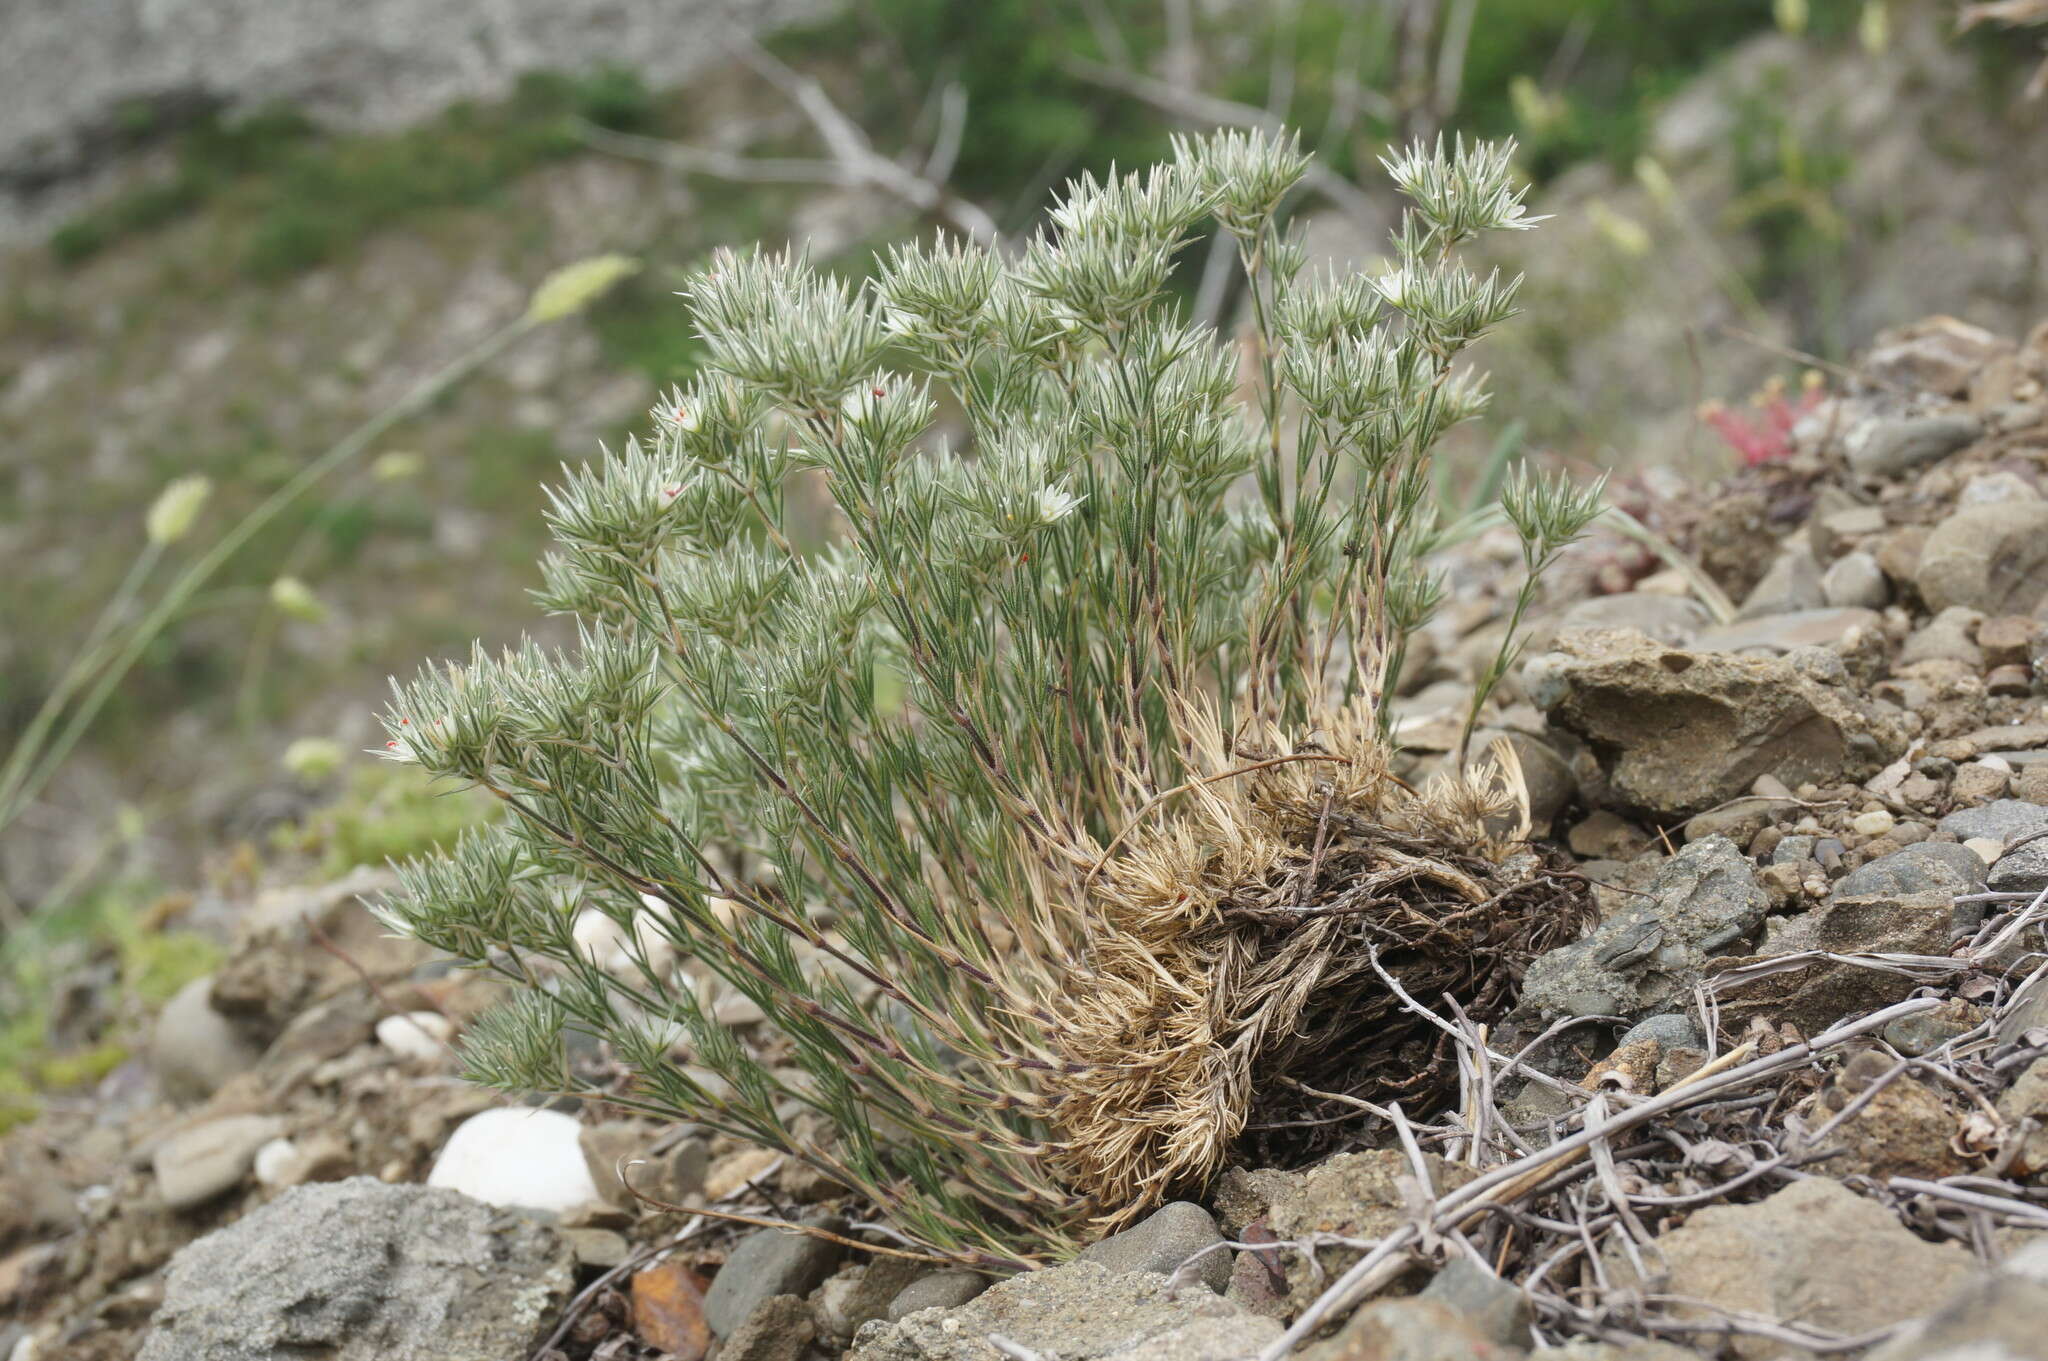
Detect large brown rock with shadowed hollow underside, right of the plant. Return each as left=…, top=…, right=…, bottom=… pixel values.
left=1524, top=632, right=1907, bottom=819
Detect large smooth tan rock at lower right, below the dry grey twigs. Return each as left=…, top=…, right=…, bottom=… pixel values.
left=1608, top=1177, right=1972, bottom=1359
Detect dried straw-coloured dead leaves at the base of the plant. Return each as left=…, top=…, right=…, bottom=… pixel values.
left=1051, top=725, right=1593, bottom=1232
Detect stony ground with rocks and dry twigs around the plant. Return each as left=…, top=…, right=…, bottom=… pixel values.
left=12, top=317, right=2048, bottom=1361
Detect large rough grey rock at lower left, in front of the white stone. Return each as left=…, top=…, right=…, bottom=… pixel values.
left=141, top=1177, right=575, bottom=1361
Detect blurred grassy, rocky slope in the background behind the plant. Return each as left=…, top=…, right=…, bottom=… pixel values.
left=0, top=0, right=2048, bottom=1039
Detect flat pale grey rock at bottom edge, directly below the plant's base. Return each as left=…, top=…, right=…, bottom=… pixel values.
left=848, top=1261, right=1280, bottom=1361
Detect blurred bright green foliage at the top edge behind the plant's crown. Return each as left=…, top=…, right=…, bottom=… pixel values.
left=774, top=0, right=1794, bottom=214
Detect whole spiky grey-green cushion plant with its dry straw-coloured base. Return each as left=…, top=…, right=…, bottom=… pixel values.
left=385, top=133, right=1595, bottom=1265
